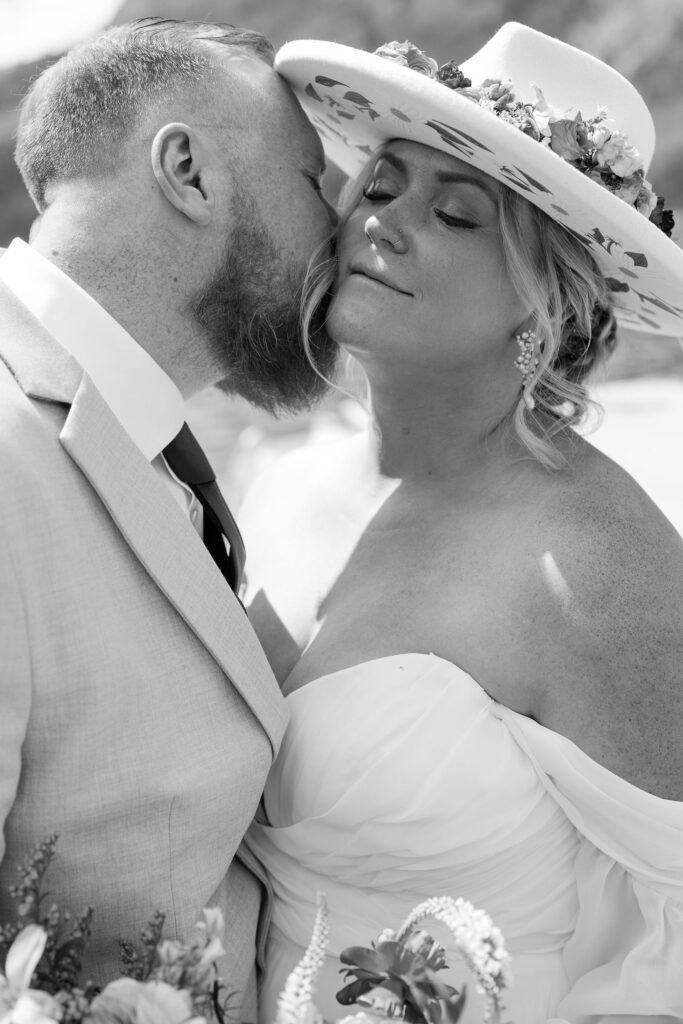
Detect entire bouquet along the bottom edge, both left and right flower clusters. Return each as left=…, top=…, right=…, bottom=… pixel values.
left=0, top=836, right=509, bottom=1024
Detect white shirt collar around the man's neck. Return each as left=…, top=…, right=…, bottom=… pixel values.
left=0, top=239, right=184, bottom=462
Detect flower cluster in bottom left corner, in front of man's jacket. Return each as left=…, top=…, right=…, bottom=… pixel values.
left=0, top=835, right=229, bottom=1024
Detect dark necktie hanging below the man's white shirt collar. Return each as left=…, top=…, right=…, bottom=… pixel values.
left=162, top=423, right=247, bottom=594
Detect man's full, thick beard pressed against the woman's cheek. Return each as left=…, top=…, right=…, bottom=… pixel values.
left=193, top=194, right=338, bottom=414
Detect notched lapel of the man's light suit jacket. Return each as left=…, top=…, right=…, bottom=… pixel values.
left=0, top=286, right=287, bottom=750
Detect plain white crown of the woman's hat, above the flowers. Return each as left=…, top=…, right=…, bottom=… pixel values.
left=460, top=22, right=654, bottom=173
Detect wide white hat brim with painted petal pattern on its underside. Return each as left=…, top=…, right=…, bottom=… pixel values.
left=275, top=40, right=683, bottom=337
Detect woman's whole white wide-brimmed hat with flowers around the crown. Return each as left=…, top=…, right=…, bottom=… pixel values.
left=274, top=22, right=683, bottom=338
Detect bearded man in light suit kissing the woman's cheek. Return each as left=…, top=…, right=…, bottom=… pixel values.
left=0, top=19, right=333, bottom=1020
